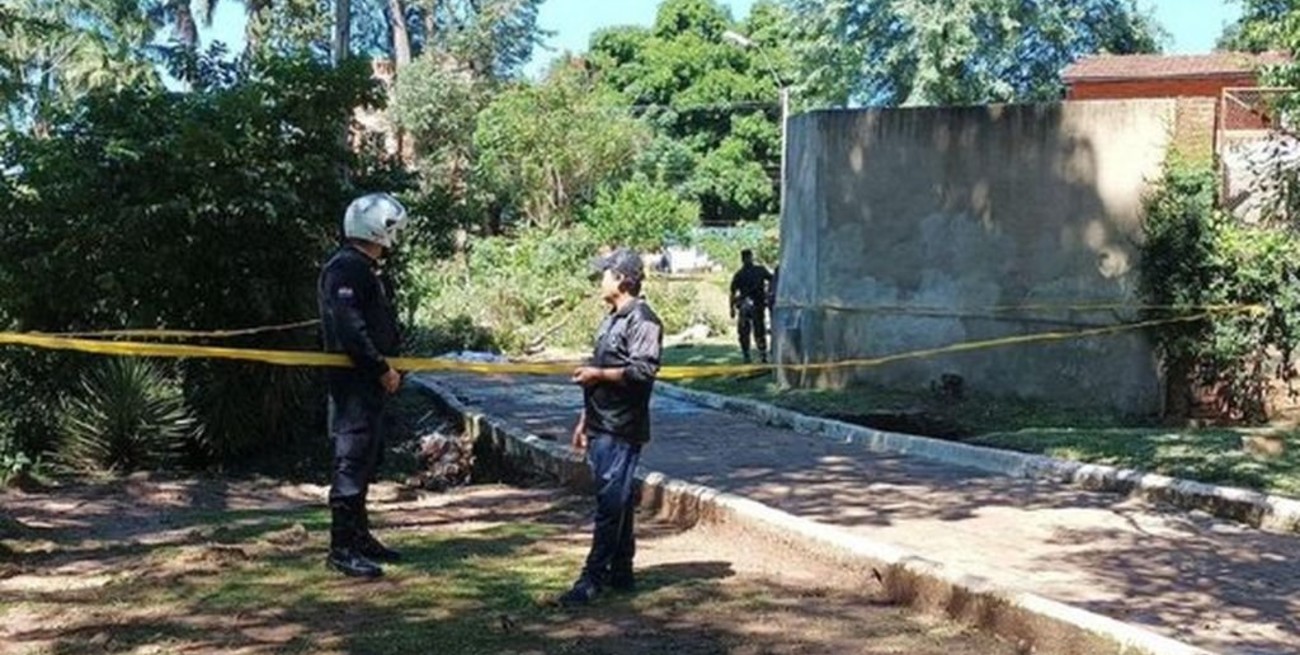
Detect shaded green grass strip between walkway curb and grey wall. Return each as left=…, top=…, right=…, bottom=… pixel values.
left=663, top=343, right=1300, bottom=496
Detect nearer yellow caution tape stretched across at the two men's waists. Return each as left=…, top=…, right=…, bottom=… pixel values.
left=0, top=307, right=1251, bottom=381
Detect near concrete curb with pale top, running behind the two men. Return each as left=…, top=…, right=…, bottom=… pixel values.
left=415, top=378, right=1213, bottom=655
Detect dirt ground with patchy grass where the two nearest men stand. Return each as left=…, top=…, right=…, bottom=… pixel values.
left=0, top=480, right=1015, bottom=655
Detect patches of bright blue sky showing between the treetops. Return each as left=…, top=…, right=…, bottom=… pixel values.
left=203, top=0, right=1240, bottom=75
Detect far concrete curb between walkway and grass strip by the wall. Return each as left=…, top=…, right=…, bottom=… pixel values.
left=655, top=383, right=1300, bottom=534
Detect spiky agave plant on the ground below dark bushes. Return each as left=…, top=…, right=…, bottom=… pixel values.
left=59, top=359, right=195, bottom=473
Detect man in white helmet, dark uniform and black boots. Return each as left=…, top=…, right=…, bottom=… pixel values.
left=317, top=194, right=406, bottom=577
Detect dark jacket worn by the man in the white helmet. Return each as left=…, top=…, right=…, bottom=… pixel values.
left=317, top=246, right=402, bottom=392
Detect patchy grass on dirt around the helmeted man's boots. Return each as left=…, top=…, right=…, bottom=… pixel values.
left=4, top=508, right=580, bottom=654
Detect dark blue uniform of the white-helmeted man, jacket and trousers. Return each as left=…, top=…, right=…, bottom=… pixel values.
left=317, top=246, right=400, bottom=548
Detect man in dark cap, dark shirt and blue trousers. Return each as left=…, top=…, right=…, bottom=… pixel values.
left=560, top=250, right=663, bottom=606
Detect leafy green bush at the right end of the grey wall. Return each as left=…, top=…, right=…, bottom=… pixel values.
left=1140, top=161, right=1300, bottom=421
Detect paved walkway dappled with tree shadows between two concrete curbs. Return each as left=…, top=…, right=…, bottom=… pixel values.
left=421, top=376, right=1300, bottom=655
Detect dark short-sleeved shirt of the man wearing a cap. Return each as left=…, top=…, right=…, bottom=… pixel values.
left=584, top=298, right=663, bottom=443
